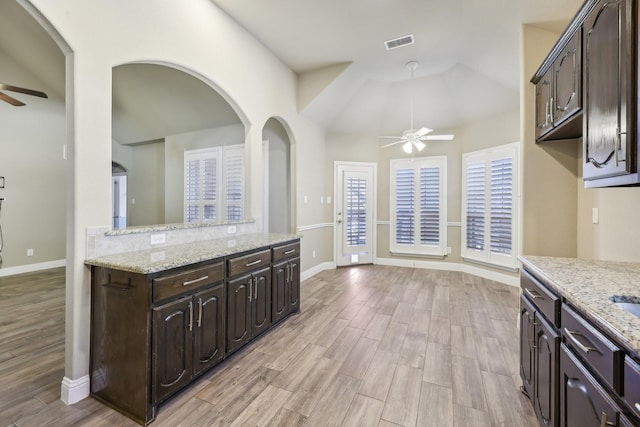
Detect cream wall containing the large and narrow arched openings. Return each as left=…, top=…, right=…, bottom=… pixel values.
left=26, top=0, right=329, bottom=403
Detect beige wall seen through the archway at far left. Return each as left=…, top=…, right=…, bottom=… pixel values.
left=0, top=52, right=68, bottom=276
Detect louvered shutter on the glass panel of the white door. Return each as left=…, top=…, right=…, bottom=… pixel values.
left=345, top=178, right=367, bottom=247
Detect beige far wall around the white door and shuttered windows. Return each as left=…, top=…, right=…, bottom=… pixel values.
left=320, top=110, right=520, bottom=276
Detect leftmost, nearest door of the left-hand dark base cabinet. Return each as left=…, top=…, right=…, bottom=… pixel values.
left=152, top=296, right=193, bottom=402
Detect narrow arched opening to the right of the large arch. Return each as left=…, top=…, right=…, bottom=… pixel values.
left=262, top=118, right=294, bottom=233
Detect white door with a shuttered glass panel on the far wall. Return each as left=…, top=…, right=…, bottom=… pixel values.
left=334, top=162, right=376, bottom=266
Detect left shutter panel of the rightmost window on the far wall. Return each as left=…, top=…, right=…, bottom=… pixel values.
left=466, top=162, right=485, bottom=251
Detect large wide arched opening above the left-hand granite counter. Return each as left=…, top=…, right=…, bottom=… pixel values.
left=112, top=63, right=248, bottom=226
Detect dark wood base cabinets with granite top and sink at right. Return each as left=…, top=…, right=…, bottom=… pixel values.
left=520, top=256, right=640, bottom=426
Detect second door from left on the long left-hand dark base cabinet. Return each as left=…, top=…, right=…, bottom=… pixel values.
left=193, top=283, right=226, bottom=375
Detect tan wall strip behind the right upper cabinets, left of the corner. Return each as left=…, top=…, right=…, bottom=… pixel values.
left=520, top=25, right=580, bottom=257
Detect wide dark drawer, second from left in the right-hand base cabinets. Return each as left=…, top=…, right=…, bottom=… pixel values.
left=562, top=304, right=624, bottom=393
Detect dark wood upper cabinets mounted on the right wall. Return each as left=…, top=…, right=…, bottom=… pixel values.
left=531, top=0, right=640, bottom=188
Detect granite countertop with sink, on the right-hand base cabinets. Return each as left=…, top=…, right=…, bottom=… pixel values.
left=519, top=256, right=640, bottom=358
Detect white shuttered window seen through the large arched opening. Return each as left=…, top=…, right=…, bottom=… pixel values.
left=184, top=145, right=244, bottom=223
